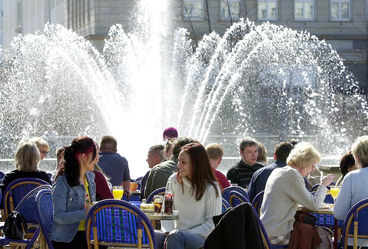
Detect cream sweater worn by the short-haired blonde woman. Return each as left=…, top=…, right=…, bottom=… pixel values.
left=261, top=166, right=327, bottom=236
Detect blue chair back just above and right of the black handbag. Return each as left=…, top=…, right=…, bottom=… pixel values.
left=15, top=185, right=51, bottom=224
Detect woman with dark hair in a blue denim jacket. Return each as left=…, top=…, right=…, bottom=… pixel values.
left=51, top=137, right=99, bottom=249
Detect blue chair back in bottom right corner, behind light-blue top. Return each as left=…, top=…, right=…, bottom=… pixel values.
left=341, top=199, right=368, bottom=248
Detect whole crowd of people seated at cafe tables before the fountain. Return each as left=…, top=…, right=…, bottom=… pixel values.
left=0, top=127, right=368, bottom=249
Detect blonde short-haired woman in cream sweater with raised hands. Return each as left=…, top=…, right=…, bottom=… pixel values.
left=261, top=142, right=333, bottom=245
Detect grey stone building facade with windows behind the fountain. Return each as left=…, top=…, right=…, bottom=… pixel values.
left=3, top=0, right=368, bottom=88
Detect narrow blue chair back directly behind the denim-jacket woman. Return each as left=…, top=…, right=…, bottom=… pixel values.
left=36, top=189, right=54, bottom=249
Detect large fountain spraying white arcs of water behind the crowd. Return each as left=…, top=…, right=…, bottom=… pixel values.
left=0, top=0, right=368, bottom=177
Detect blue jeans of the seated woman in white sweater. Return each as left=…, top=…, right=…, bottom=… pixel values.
left=155, top=230, right=205, bottom=249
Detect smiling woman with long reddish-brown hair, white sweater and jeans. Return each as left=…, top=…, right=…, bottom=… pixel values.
left=156, top=143, right=221, bottom=249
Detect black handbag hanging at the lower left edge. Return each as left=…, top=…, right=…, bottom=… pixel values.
left=3, top=211, right=27, bottom=240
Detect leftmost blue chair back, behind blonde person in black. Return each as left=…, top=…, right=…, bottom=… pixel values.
left=3, top=178, right=49, bottom=217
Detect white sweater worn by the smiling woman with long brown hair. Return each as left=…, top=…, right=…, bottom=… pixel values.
left=161, top=173, right=221, bottom=238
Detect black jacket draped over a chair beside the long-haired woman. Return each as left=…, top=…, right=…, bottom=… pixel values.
left=204, top=202, right=265, bottom=249
